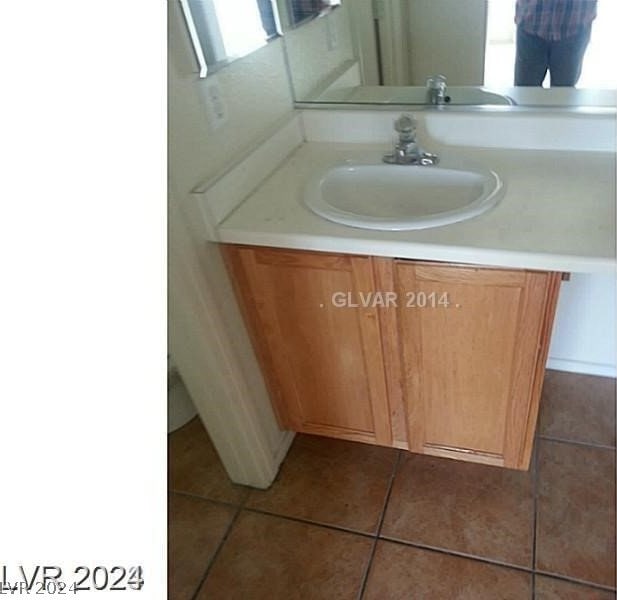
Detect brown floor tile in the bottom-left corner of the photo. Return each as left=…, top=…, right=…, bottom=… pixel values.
left=168, top=494, right=236, bottom=600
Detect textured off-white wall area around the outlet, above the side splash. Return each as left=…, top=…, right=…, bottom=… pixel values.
left=168, top=2, right=293, bottom=195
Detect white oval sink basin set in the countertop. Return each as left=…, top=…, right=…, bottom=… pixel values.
left=304, top=161, right=503, bottom=231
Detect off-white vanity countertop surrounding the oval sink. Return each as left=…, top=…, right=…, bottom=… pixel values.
left=218, top=142, right=617, bottom=273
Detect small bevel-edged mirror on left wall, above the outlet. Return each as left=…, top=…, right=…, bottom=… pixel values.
left=179, top=0, right=280, bottom=77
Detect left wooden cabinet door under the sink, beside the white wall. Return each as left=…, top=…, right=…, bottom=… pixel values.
left=224, top=245, right=392, bottom=445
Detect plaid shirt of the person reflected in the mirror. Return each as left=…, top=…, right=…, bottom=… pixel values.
left=514, top=0, right=596, bottom=41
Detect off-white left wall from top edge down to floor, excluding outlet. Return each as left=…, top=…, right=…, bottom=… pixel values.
left=168, top=1, right=293, bottom=487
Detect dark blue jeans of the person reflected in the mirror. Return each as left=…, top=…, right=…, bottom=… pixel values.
left=514, top=24, right=591, bottom=87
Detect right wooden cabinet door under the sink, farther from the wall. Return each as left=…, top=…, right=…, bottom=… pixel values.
left=394, top=261, right=560, bottom=469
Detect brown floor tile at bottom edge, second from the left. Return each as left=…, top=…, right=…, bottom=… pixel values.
left=198, top=511, right=372, bottom=600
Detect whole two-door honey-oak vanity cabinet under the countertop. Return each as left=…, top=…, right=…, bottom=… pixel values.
left=223, top=245, right=561, bottom=469
